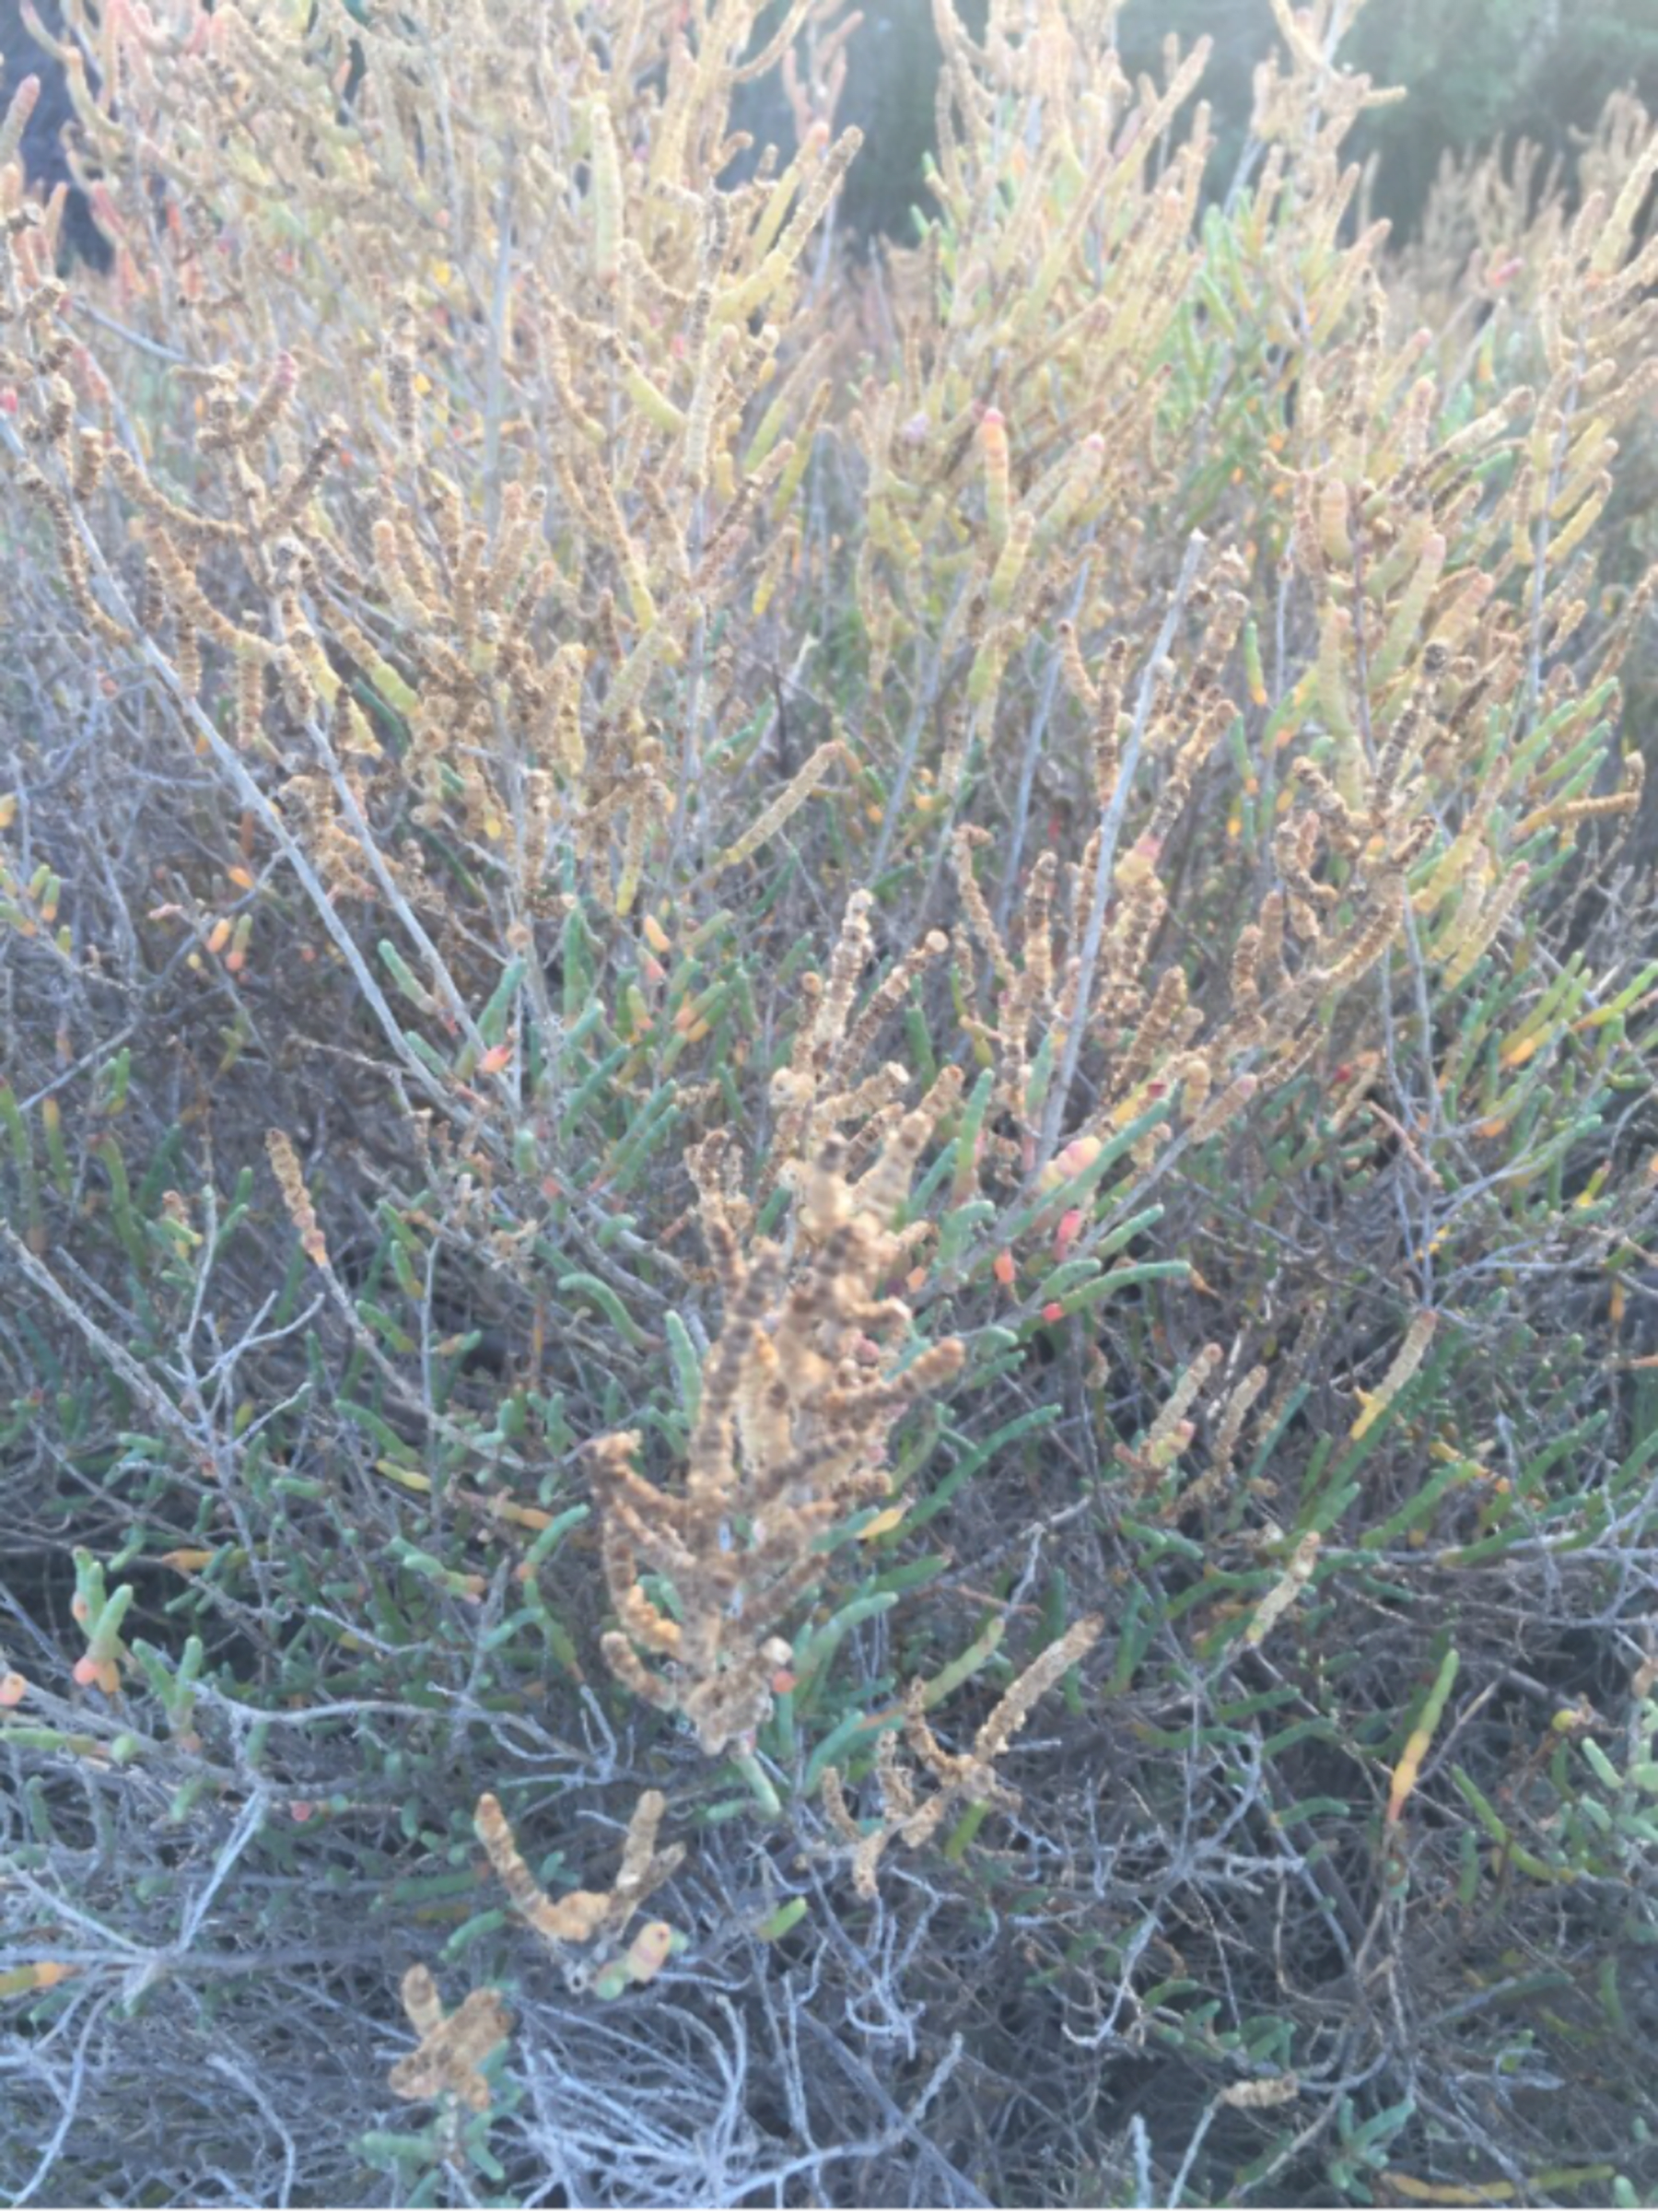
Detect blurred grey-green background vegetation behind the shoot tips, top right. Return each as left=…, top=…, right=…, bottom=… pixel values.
left=747, top=0, right=1658, bottom=241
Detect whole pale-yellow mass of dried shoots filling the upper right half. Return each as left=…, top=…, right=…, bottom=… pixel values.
left=849, top=6, right=1658, bottom=1247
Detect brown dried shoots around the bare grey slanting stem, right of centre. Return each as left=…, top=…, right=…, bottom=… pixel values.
left=952, top=528, right=1432, bottom=1176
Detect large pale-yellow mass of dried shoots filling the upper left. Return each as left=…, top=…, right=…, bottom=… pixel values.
left=0, top=0, right=875, bottom=1088
